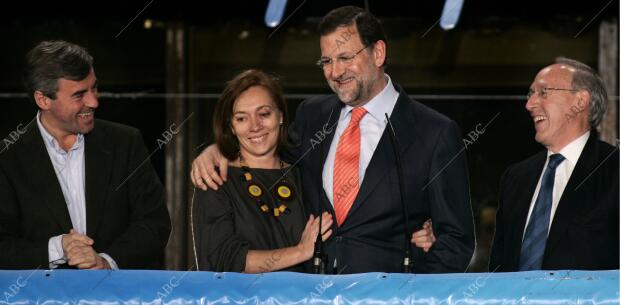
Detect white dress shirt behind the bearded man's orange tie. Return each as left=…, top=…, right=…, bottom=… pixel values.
left=323, top=74, right=399, bottom=205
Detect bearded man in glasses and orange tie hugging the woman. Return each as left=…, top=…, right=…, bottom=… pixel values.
left=192, top=6, right=474, bottom=273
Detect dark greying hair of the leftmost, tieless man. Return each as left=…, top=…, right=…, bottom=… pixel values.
left=24, top=40, right=93, bottom=99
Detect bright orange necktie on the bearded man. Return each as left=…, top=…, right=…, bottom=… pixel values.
left=334, top=107, right=367, bottom=226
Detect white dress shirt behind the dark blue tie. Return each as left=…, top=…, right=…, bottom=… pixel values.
left=523, top=131, right=590, bottom=236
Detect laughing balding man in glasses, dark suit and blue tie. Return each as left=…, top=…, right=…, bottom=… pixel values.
left=489, top=58, right=619, bottom=271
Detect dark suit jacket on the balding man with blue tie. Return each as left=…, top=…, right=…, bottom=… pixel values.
left=489, top=131, right=618, bottom=271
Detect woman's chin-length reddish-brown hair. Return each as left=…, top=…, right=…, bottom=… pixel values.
left=213, top=69, right=289, bottom=161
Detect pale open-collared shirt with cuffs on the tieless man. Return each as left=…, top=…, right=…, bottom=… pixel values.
left=37, top=112, right=118, bottom=269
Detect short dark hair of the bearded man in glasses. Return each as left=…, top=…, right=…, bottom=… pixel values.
left=319, top=6, right=387, bottom=62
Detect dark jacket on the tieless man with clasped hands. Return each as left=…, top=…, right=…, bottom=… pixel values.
left=0, top=120, right=170, bottom=269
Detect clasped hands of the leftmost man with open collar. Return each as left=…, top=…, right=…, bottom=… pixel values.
left=62, top=229, right=111, bottom=269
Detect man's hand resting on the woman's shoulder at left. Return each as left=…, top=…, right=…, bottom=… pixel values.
left=190, top=144, right=228, bottom=191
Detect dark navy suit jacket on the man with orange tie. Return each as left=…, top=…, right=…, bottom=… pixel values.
left=292, top=86, right=474, bottom=273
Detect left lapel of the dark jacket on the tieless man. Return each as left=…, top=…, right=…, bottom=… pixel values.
left=19, top=122, right=73, bottom=233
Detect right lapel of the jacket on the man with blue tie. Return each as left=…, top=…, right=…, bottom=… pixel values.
left=545, top=131, right=598, bottom=253
